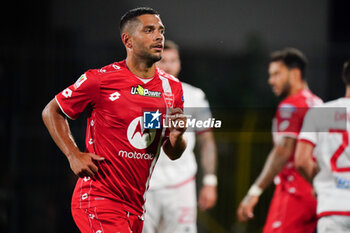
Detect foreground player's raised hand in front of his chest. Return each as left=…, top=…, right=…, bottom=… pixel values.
left=168, top=108, right=187, bottom=136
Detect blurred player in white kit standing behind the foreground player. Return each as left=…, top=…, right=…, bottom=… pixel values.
left=143, top=40, right=217, bottom=233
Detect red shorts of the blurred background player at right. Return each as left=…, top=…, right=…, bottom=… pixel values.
left=263, top=186, right=317, bottom=233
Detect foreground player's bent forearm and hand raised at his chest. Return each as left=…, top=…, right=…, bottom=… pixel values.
left=163, top=108, right=187, bottom=160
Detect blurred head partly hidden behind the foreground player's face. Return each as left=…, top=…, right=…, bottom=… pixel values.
left=156, top=40, right=181, bottom=77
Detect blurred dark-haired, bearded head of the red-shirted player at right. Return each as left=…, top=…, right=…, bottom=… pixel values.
left=268, top=48, right=307, bottom=97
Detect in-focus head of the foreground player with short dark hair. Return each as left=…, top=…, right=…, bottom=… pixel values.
left=119, top=7, right=165, bottom=64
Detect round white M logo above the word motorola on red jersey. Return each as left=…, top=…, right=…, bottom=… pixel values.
left=127, top=116, right=157, bottom=149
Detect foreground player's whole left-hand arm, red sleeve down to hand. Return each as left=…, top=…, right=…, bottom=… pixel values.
left=42, top=70, right=103, bottom=177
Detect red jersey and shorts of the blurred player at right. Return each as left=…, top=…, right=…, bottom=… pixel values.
left=263, top=90, right=322, bottom=233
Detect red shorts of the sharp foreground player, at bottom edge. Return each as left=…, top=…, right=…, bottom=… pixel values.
left=72, top=207, right=143, bottom=233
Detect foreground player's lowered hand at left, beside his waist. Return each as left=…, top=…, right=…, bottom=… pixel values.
left=68, top=152, right=104, bottom=178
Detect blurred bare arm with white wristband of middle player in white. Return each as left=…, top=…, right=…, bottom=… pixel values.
left=197, top=131, right=217, bottom=210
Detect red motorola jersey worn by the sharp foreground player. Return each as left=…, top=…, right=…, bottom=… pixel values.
left=56, top=61, right=183, bottom=216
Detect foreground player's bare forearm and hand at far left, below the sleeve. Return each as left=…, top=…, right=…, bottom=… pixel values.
left=42, top=99, right=104, bottom=177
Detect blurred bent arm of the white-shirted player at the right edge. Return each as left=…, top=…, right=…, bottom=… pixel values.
left=295, top=140, right=319, bottom=183
